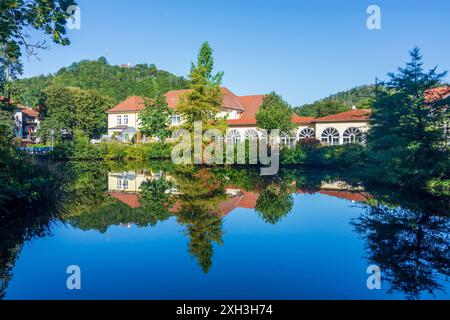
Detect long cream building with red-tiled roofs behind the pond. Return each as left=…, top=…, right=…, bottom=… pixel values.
left=107, top=87, right=371, bottom=145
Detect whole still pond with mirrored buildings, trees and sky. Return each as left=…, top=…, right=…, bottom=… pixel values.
left=0, top=163, right=450, bottom=299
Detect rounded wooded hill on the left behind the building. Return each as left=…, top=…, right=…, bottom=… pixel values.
left=14, top=57, right=188, bottom=106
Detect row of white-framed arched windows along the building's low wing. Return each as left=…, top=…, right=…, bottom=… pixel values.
left=227, top=127, right=363, bottom=146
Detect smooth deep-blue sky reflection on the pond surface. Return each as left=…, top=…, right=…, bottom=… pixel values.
left=6, top=194, right=450, bottom=299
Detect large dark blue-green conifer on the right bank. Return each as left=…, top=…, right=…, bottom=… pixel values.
left=367, top=48, right=450, bottom=187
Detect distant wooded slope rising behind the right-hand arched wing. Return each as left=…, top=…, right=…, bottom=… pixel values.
left=294, top=85, right=375, bottom=117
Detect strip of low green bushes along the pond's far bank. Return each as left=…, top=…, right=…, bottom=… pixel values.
left=49, top=138, right=450, bottom=197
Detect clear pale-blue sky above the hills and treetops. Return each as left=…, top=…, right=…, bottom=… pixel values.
left=24, top=0, right=450, bottom=106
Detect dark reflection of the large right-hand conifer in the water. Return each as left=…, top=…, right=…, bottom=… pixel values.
left=353, top=195, right=450, bottom=299
